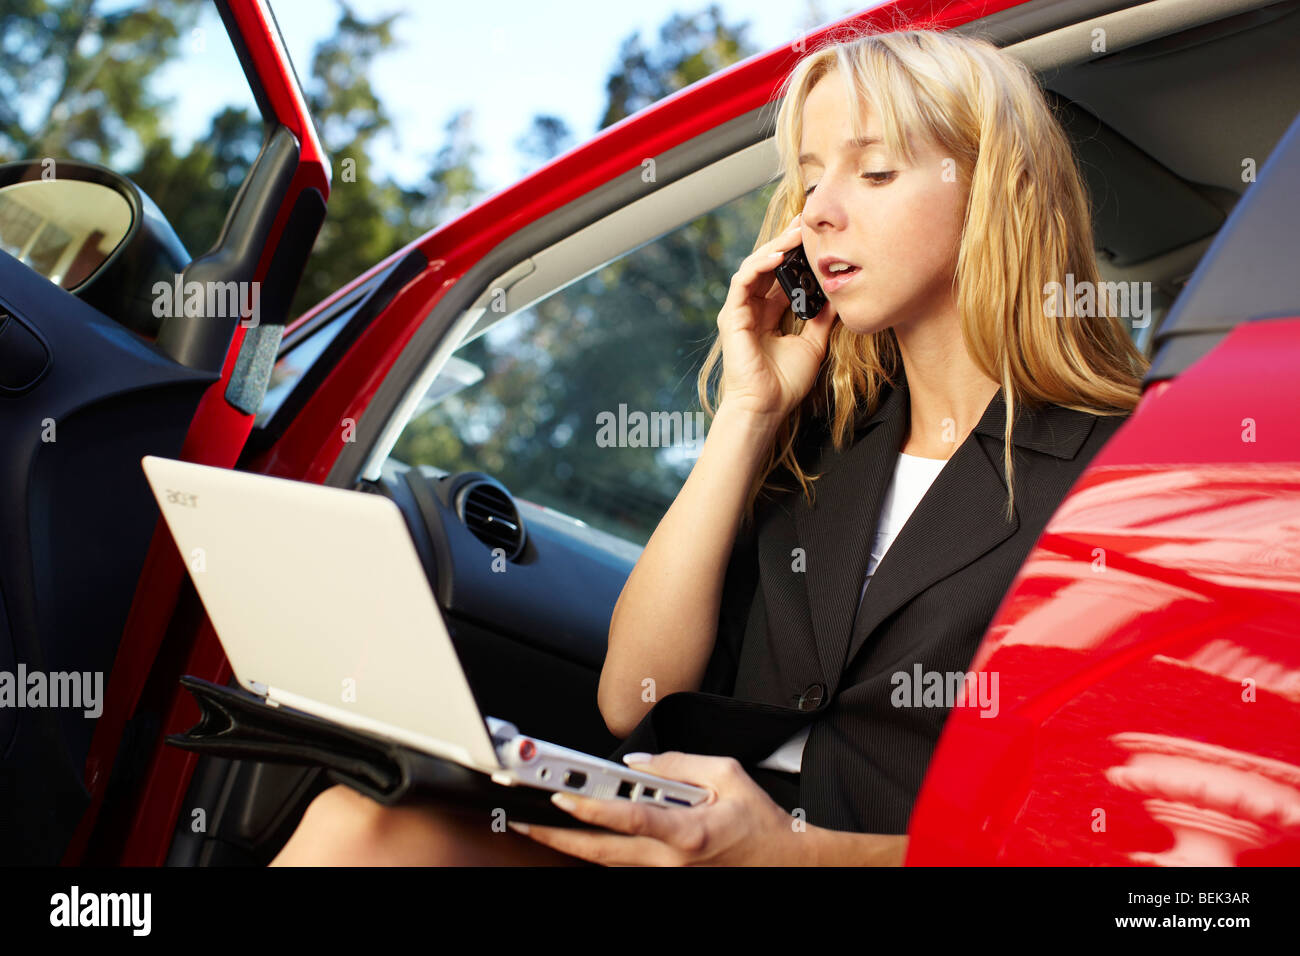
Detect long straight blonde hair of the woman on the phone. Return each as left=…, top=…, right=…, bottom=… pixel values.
left=698, top=30, right=1148, bottom=520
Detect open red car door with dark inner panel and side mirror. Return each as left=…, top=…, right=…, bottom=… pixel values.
left=0, top=0, right=329, bottom=865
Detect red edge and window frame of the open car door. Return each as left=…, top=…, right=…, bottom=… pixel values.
left=55, top=0, right=330, bottom=864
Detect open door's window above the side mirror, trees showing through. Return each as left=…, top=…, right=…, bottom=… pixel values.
left=0, top=0, right=264, bottom=256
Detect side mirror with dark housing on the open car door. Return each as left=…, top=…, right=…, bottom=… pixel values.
left=0, top=160, right=190, bottom=338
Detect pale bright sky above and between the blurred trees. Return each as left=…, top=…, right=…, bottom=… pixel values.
left=159, top=0, right=875, bottom=193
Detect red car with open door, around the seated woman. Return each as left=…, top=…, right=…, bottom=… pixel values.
left=0, top=0, right=1300, bottom=865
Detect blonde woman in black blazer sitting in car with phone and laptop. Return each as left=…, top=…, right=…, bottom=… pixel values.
left=274, top=30, right=1147, bottom=865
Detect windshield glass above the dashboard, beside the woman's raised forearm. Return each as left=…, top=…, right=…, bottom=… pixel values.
left=393, top=185, right=775, bottom=545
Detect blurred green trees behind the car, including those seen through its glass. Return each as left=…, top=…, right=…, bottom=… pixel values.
left=0, top=0, right=768, bottom=541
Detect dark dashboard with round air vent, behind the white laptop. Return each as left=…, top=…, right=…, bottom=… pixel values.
left=361, top=459, right=641, bottom=756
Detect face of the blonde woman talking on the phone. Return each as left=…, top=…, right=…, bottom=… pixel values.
left=800, top=72, right=966, bottom=334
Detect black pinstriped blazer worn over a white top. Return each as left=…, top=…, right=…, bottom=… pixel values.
left=614, top=372, right=1127, bottom=834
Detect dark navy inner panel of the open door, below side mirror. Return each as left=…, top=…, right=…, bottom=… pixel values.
left=0, top=254, right=217, bottom=862
